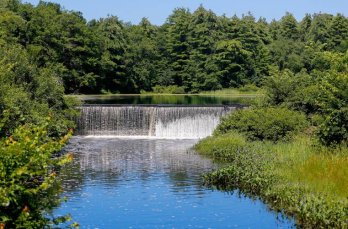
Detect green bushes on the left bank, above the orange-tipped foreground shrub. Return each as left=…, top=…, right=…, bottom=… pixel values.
left=0, top=41, right=74, bottom=136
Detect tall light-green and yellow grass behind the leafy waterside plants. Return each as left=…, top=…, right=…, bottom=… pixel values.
left=273, top=136, right=348, bottom=200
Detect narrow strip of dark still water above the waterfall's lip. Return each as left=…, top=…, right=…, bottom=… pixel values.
left=78, top=95, right=255, bottom=105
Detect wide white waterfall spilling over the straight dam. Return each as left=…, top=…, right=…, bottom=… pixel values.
left=77, top=105, right=236, bottom=139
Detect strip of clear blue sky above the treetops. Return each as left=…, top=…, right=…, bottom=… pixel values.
left=23, top=0, right=348, bottom=25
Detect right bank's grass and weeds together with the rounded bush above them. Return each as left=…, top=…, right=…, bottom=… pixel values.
left=196, top=108, right=348, bottom=228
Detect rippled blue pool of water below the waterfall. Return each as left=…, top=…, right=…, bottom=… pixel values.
left=55, top=137, right=294, bottom=228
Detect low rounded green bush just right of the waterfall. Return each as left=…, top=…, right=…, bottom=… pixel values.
left=214, top=108, right=307, bottom=141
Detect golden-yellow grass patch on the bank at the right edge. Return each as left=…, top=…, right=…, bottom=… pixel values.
left=278, top=145, right=348, bottom=200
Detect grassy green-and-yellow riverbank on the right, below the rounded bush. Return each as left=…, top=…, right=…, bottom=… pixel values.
left=195, top=132, right=348, bottom=228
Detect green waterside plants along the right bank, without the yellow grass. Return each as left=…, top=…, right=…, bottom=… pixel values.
left=195, top=133, right=348, bottom=228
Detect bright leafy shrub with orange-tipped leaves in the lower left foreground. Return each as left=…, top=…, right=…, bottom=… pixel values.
left=0, top=123, right=72, bottom=228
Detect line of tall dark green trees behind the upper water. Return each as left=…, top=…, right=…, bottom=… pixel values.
left=0, top=0, right=348, bottom=94
